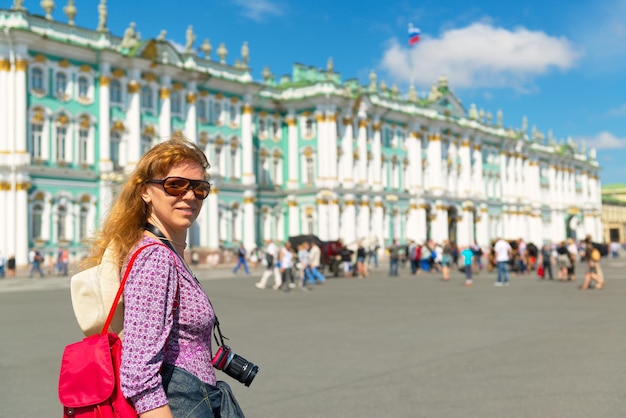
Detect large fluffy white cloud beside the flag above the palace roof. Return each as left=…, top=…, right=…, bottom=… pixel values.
left=380, top=22, right=580, bottom=90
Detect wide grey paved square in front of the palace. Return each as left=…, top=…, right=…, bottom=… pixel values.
left=0, top=259, right=626, bottom=418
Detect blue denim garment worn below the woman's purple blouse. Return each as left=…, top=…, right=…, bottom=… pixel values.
left=161, top=364, right=244, bottom=418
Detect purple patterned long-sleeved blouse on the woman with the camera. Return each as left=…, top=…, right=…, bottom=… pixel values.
left=120, top=237, right=216, bottom=414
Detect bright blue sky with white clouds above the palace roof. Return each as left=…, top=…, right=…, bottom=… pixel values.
left=19, top=0, right=626, bottom=184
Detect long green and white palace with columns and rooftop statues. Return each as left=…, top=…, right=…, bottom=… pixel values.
left=0, top=0, right=603, bottom=264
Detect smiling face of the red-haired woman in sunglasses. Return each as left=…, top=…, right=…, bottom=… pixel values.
left=142, top=161, right=205, bottom=233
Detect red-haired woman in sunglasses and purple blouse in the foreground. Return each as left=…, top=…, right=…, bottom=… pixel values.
left=83, top=137, right=239, bottom=418
